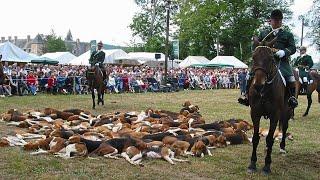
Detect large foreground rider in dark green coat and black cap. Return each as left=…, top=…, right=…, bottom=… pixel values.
left=238, top=9, right=298, bottom=108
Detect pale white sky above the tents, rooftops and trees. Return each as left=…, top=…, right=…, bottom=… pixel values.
left=0, top=0, right=320, bottom=60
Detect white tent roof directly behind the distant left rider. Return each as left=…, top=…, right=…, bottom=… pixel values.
left=69, top=49, right=128, bottom=66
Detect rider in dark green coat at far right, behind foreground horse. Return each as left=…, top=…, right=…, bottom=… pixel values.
left=294, top=46, right=313, bottom=87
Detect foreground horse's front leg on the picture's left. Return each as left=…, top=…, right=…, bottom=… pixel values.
left=248, top=114, right=261, bottom=173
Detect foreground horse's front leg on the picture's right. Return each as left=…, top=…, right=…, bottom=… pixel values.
left=262, top=111, right=280, bottom=175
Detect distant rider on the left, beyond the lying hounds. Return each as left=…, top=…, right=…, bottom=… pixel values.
left=89, top=41, right=106, bottom=79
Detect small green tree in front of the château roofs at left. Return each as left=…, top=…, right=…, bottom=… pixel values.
left=43, top=30, right=67, bottom=53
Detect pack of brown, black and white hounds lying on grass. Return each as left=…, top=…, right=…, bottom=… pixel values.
left=0, top=101, right=292, bottom=166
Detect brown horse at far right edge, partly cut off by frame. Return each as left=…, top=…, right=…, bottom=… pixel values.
left=293, top=71, right=320, bottom=117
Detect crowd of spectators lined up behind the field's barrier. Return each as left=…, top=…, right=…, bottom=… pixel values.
left=0, top=63, right=248, bottom=97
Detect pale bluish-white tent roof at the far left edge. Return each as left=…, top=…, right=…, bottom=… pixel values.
left=0, top=41, right=34, bottom=62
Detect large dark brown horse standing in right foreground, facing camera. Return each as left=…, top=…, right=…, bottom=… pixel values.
left=248, top=38, right=293, bottom=174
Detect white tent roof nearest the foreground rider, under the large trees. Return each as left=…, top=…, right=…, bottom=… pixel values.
left=208, top=56, right=248, bottom=69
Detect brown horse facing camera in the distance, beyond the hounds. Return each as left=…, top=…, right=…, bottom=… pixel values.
left=87, top=66, right=105, bottom=109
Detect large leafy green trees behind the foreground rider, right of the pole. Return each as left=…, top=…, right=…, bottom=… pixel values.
left=175, top=0, right=292, bottom=59
